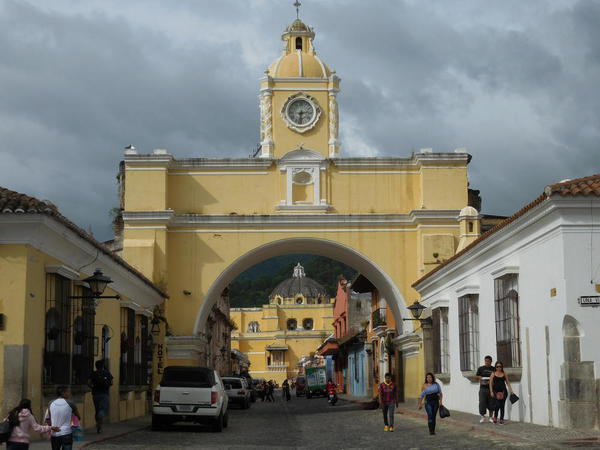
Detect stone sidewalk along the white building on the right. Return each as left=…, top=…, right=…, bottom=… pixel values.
left=338, top=394, right=600, bottom=448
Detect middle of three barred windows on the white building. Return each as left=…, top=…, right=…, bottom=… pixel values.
left=458, top=294, right=479, bottom=370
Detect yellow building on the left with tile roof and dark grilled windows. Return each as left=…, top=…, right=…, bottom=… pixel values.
left=0, top=187, right=166, bottom=427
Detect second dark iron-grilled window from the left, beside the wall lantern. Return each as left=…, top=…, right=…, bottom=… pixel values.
left=71, top=286, right=95, bottom=385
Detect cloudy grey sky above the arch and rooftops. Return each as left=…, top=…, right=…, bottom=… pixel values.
left=0, top=0, right=600, bottom=239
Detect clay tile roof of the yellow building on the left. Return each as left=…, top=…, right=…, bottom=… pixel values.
left=0, top=186, right=168, bottom=298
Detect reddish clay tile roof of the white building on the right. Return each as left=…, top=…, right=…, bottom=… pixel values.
left=412, top=174, right=600, bottom=288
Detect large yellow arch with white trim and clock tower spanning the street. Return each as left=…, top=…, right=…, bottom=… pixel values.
left=120, top=15, right=470, bottom=397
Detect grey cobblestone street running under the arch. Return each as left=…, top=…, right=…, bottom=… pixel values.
left=83, top=397, right=598, bottom=449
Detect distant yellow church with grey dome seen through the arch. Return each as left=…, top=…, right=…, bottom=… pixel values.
left=230, top=264, right=335, bottom=384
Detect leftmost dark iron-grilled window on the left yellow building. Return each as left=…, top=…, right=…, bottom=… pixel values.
left=43, top=273, right=71, bottom=384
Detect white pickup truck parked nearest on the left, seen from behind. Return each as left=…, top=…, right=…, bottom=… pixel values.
left=152, top=366, right=228, bottom=432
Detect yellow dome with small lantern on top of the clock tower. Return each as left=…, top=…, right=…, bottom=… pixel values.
left=268, top=19, right=332, bottom=78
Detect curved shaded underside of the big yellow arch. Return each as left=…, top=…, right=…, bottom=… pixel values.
left=193, top=238, right=414, bottom=335
